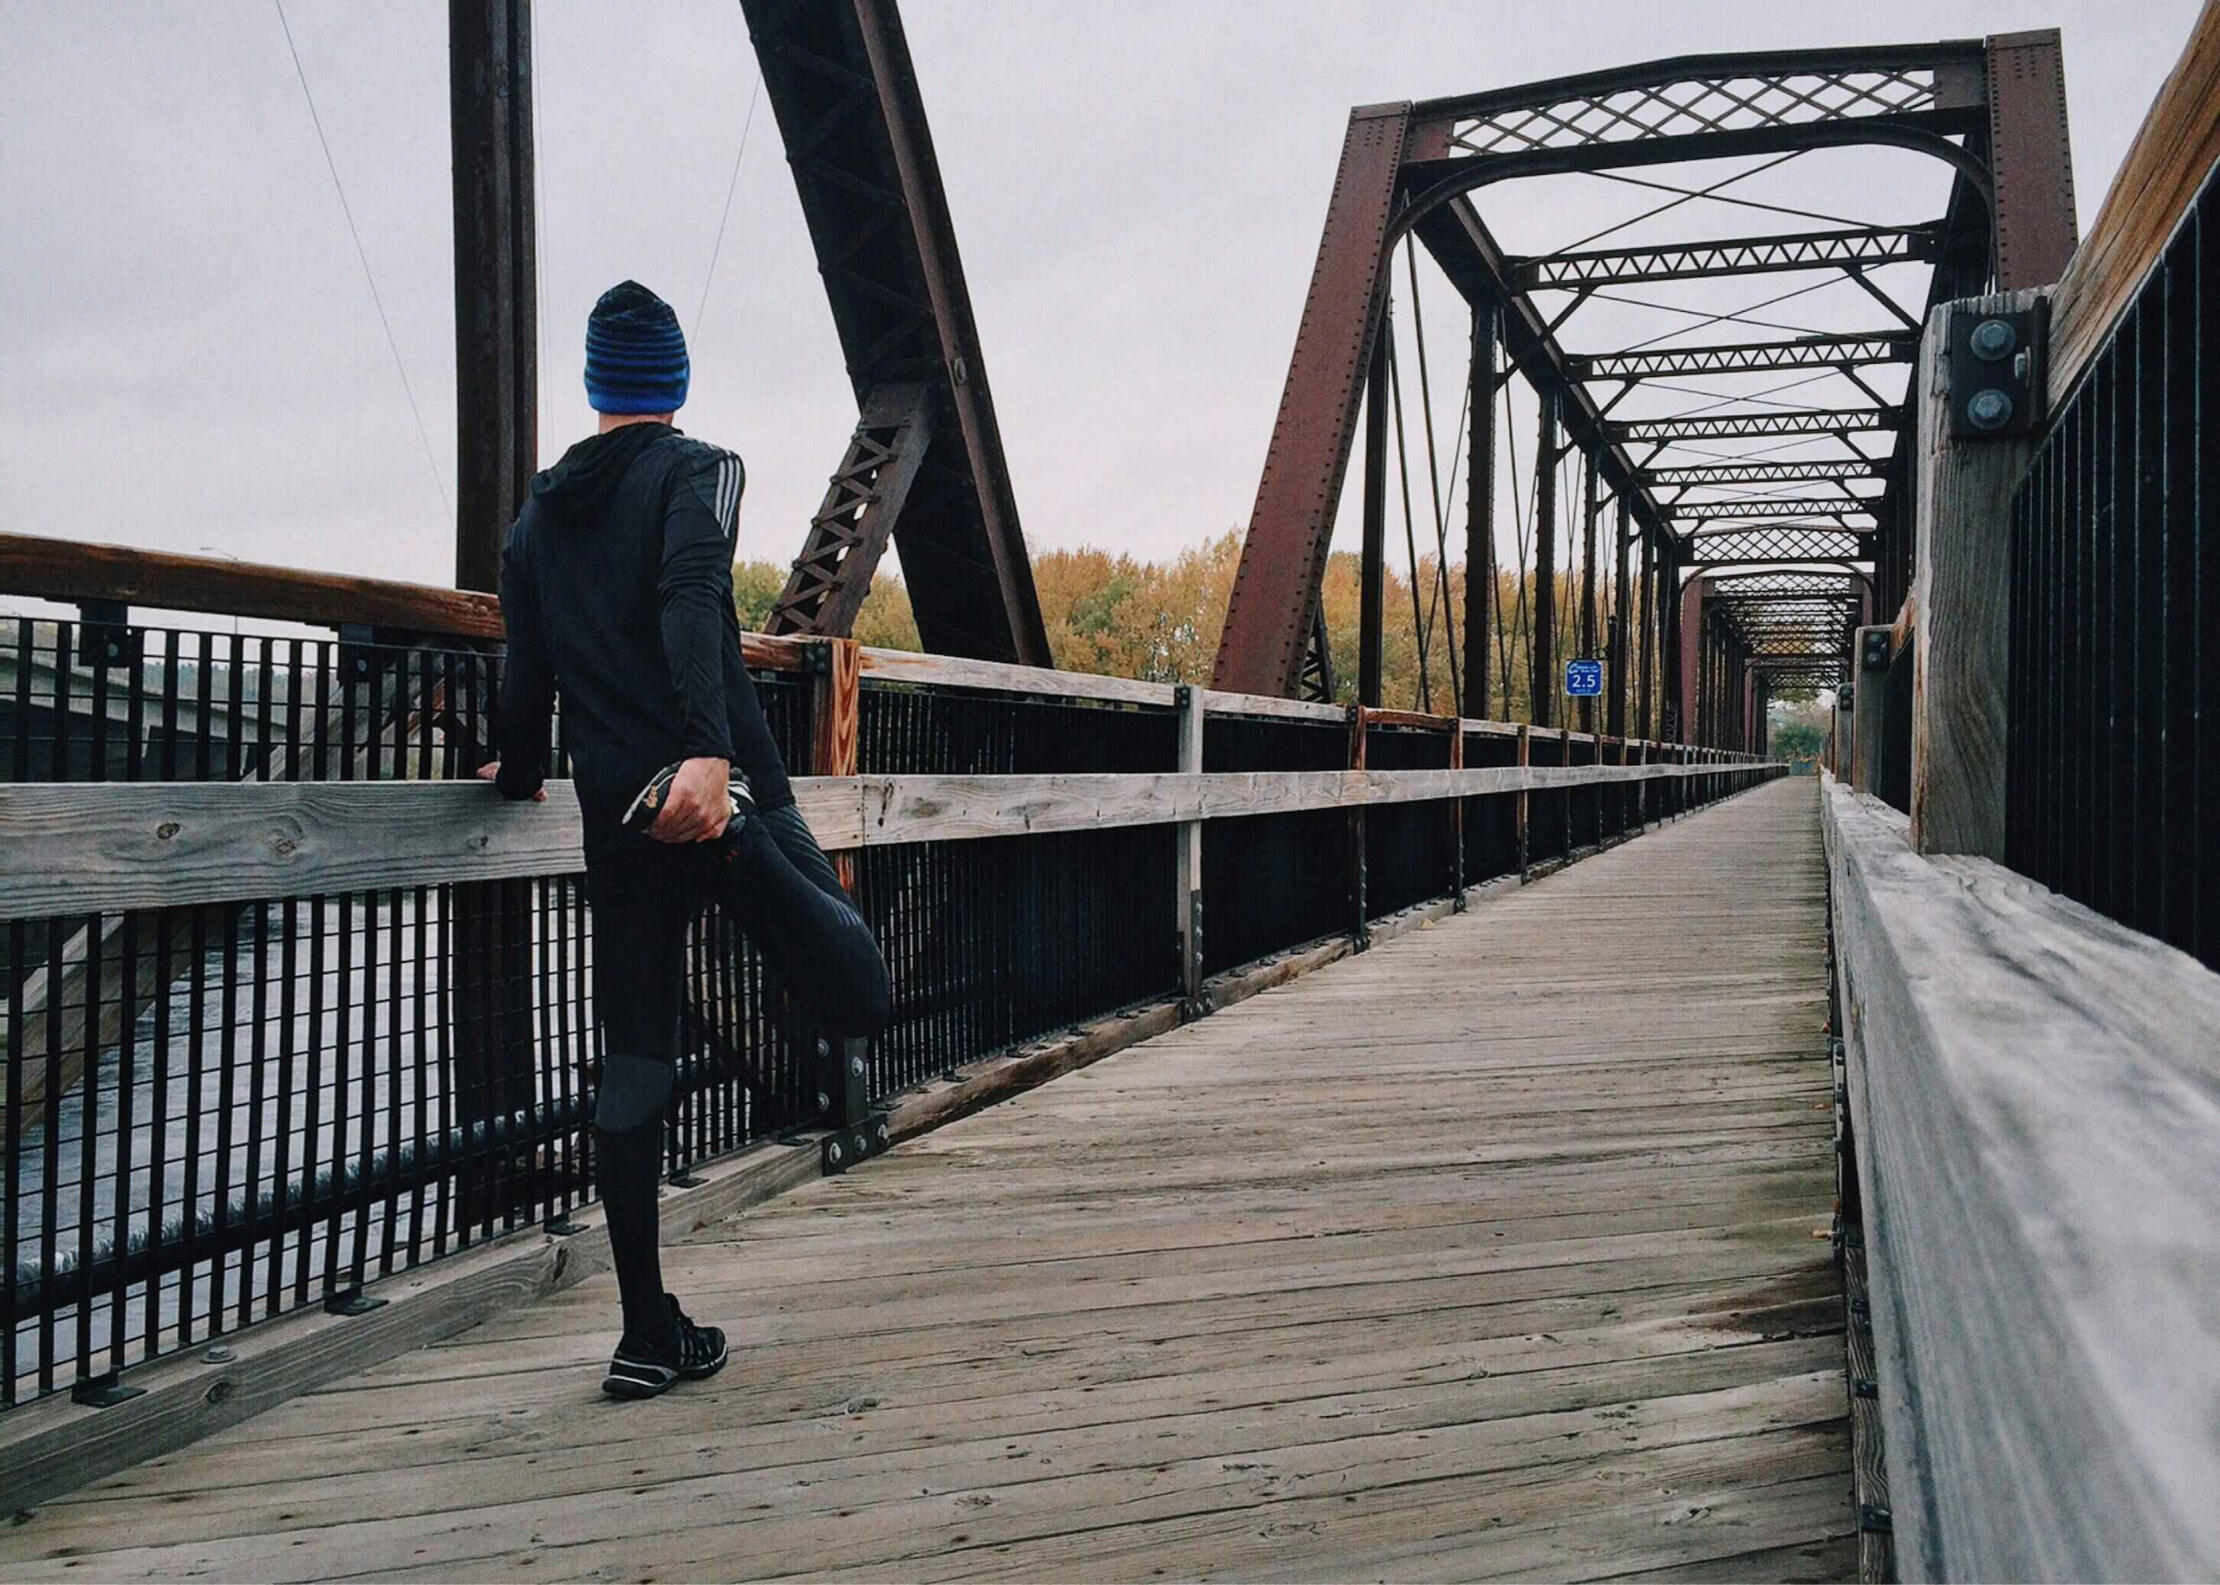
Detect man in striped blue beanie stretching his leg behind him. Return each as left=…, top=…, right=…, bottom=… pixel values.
left=480, top=282, right=888, bottom=1399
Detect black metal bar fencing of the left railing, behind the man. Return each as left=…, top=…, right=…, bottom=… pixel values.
left=0, top=603, right=1767, bottom=1405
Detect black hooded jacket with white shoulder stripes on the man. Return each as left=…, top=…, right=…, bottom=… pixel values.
left=497, top=424, right=793, bottom=859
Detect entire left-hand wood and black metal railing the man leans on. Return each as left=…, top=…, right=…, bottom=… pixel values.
left=0, top=537, right=1774, bottom=1399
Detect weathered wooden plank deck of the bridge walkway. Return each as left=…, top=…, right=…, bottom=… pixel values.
left=0, top=779, right=1856, bottom=1578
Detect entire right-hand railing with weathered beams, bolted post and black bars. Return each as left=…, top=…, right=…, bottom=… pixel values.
left=1825, top=2, right=2220, bottom=1578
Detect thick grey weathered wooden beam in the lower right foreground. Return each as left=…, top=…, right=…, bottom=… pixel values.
left=1825, top=779, right=2220, bottom=1578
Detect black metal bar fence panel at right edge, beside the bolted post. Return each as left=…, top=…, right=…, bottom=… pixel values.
left=2007, top=169, right=2220, bottom=968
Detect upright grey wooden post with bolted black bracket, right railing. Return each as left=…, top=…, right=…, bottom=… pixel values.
left=1909, top=291, right=2045, bottom=859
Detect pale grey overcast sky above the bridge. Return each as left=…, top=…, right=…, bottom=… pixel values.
left=0, top=0, right=2196, bottom=599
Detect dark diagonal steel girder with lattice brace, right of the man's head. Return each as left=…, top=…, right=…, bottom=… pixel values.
left=741, top=0, right=1050, bottom=666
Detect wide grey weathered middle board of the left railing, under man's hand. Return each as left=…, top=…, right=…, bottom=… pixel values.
left=0, top=766, right=1767, bottom=919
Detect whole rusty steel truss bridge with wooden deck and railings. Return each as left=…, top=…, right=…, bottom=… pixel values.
left=0, top=0, right=2220, bottom=1581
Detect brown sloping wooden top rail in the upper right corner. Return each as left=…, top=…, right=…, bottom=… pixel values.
left=2047, top=0, right=2220, bottom=413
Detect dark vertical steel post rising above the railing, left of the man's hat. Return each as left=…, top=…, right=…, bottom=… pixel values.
left=446, top=0, right=539, bottom=590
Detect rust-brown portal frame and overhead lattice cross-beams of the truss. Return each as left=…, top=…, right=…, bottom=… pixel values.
left=1217, top=33, right=2071, bottom=710
